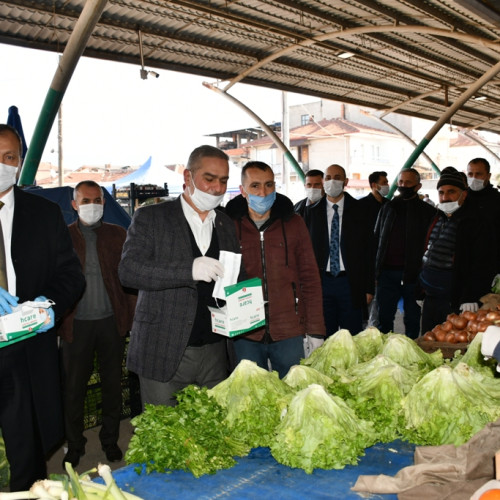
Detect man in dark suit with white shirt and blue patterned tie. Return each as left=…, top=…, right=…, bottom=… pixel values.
left=304, top=165, right=375, bottom=335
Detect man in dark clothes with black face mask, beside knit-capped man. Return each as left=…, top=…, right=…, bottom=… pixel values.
left=375, top=168, right=436, bottom=339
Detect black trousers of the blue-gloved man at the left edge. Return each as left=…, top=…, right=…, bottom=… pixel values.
left=0, top=342, right=45, bottom=491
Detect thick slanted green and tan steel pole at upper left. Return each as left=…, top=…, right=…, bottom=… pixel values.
left=19, top=0, right=107, bottom=186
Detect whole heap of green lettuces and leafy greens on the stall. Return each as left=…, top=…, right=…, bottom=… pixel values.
left=126, top=328, right=500, bottom=477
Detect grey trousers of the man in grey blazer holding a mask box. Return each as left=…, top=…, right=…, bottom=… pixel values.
left=139, top=339, right=228, bottom=410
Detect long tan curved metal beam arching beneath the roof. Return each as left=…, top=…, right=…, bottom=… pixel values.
left=224, top=25, right=500, bottom=91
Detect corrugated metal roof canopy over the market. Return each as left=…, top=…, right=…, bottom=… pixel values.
left=0, top=0, right=500, bottom=133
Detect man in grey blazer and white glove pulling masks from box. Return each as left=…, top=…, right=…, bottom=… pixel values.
left=119, top=146, right=240, bottom=405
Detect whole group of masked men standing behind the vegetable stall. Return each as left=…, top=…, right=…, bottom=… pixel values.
left=0, top=125, right=500, bottom=490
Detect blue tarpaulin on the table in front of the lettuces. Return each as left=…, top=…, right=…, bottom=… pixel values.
left=108, top=441, right=415, bottom=500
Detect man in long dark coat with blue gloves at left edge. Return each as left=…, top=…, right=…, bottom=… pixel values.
left=0, top=125, right=85, bottom=490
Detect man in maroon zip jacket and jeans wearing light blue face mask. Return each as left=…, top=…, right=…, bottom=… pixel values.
left=226, top=161, right=325, bottom=377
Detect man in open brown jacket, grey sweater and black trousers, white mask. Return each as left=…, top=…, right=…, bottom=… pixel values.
left=58, top=181, right=136, bottom=468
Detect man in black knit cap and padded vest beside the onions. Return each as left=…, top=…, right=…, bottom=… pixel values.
left=420, top=167, right=497, bottom=332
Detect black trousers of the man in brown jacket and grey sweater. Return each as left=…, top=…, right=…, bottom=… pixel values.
left=62, top=316, right=125, bottom=450
